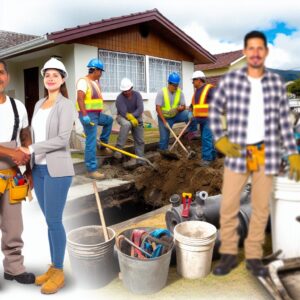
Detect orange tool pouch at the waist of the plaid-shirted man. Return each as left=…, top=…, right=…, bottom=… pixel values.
left=246, top=141, right=265, bottom=172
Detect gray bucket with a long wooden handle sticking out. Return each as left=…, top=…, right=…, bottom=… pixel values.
left=67, top=225, right=118, bottom=288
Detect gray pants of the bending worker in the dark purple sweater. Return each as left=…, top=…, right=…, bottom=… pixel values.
left=116, top=116, right=145, bottom=157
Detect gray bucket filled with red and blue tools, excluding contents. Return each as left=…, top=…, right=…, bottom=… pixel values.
left=115, top=227, right=173, bottom=294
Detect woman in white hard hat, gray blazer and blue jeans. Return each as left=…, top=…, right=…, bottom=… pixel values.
left=21, top=58, right=76, bottom=294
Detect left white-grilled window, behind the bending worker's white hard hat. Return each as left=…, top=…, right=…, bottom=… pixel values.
left=99, top=50, right=146, bottom=93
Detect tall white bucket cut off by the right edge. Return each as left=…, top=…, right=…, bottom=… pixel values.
left=271, top=176, right=300, bottom=258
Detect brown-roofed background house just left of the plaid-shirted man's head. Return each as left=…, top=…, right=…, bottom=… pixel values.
left=195, top=50, right=246, bottom=85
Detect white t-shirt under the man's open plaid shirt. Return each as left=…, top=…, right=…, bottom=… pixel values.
left=246, top=76, right=265, bottom=144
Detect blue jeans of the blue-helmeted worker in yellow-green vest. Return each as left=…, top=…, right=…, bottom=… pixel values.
left=158, top=110, right=189, bottom=150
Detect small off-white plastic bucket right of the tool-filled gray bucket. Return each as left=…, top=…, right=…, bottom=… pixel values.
left=174, top=221, right=217, bottom=279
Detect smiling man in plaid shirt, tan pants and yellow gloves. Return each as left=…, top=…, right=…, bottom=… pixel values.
left=209, top=31, right=300, bottom=276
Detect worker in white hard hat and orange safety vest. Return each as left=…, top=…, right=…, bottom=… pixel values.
left=189, top=71, right=216, bottom=167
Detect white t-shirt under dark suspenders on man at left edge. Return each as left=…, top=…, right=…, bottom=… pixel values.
left=0, top=96, right=28, bottom=146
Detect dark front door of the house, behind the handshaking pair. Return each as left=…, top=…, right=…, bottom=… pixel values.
left=24, top=67, right=39, bottom=124
